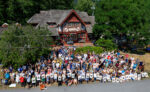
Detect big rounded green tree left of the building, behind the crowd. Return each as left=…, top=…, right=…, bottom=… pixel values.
left=0, top=26, right=52, bottom=68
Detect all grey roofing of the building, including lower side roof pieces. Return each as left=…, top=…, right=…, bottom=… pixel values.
left=27, top=9, right=95, bottom=36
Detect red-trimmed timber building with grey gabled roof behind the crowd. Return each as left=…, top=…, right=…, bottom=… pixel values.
left=27, top=10, right=95, bottom=45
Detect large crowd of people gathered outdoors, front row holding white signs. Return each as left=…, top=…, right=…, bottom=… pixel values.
left=2, top=47, right=148, bottom=87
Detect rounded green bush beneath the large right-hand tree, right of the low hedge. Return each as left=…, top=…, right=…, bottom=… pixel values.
left=96, top=39, right=117, bottom=51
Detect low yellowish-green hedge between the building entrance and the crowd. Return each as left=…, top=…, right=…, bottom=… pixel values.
left=75, top=46, right=103, bottom=54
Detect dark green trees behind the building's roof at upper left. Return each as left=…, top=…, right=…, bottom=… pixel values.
left=0, top=0, right=73, bottom=25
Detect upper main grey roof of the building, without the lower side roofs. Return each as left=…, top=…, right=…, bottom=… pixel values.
left=27, top=10, right=95, bottom=26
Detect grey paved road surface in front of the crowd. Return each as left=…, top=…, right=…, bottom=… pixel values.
left=0, top=80, right=150, bottom=92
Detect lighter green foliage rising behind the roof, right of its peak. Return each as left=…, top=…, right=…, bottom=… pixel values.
left=75, top=0, right=94, bottom=15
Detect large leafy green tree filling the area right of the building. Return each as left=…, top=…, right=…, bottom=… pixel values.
left=93, top=0, right=150, bottom=50
